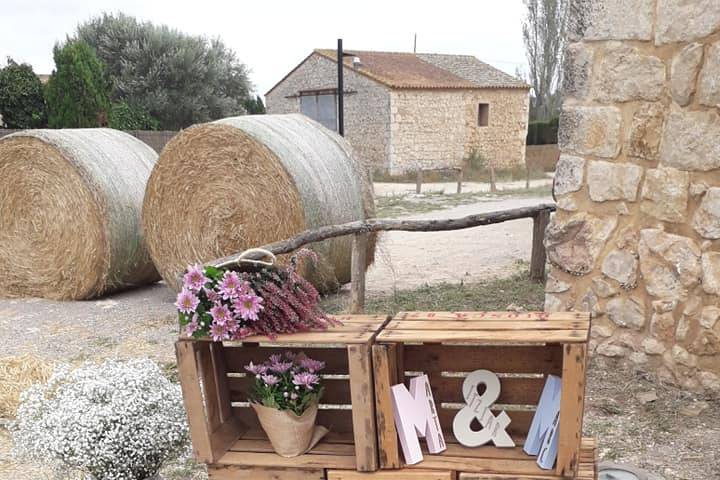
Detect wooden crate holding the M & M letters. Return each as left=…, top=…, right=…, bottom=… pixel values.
left=373, top=312, right=590, bottom=479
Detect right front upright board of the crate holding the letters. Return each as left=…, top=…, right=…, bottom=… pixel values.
left=556, top=345, right=587, bottom=477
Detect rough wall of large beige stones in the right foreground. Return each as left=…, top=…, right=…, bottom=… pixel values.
left=546, top=0, right=720, bottom=391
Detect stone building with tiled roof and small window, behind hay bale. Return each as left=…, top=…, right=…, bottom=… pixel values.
left=265, top=50, right=529, bottom=174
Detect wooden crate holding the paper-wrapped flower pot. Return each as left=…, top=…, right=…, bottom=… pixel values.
left=175, top=315, right=388, bottom=479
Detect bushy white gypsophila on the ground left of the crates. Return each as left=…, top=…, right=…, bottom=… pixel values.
left=11, top=359, right=188, bottom=480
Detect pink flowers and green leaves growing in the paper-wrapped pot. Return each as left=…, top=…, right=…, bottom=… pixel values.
left=245, top=352, right=325, bottom=415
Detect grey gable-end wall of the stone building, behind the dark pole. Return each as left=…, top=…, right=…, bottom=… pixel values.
left=265, top=54, right=390, bottom=169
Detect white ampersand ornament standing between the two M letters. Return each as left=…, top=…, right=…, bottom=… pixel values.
left=453, top=370, right=515, bottom=447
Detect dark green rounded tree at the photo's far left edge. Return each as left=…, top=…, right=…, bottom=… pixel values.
left=0, top=58, right=47, bottom=128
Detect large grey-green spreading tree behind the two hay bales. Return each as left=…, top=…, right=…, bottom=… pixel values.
left=77, top=14, right=252, bottom=130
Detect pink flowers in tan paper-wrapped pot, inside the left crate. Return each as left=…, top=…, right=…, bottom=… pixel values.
left=245, top=352, right=327, bottom=457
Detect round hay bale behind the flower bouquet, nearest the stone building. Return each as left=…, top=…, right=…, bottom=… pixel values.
left=143, top=114, right=375, bottom=291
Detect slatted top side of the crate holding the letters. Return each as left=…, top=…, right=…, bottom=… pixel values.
left=377, top=312, right=590, bottom=343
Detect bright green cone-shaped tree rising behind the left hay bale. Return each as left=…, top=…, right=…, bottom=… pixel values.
left=45, top=40, right=110, bottom=128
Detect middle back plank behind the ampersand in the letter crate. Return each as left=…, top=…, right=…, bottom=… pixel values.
left=408, top=374, right=545, bottom=405
